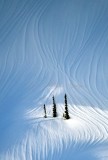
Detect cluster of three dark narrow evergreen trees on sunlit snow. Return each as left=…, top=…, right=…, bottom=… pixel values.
left=44, top=94, right=70, bottom=119
